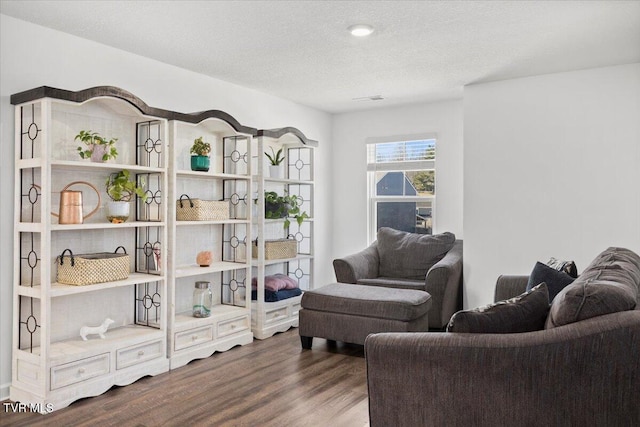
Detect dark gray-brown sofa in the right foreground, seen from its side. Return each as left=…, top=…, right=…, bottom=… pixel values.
left=365, top=248, right=640, bottom=427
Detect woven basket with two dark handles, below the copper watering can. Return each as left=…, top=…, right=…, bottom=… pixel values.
left=56, top=246, right=129, bottom=286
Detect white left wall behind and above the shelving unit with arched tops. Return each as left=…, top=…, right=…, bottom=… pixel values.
left=0, top=15, right=331, bottom=400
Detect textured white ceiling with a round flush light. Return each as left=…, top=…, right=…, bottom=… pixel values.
left=0, top=0, right=640, bottom=113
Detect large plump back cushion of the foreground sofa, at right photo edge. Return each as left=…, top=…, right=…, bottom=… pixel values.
left=545, top=248, right=640, bottom=329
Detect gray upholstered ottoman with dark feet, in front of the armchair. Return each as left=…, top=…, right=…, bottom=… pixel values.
left=298, top=283, right=431, bottom=349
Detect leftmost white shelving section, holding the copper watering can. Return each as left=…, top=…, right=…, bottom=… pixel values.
left=10, top=87, right=169, bottom=412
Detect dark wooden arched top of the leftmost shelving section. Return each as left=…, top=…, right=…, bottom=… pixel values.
left=11, top=86, right=174, bottom=119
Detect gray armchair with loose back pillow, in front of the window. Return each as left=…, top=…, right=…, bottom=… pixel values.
left=333, top=227, right=462, bottom=329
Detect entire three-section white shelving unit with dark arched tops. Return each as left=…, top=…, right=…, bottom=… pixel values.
left=10, top=86, right=317, bottom=413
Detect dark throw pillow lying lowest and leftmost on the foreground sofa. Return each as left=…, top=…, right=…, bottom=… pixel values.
left=447, top=283, right=549, bottom=334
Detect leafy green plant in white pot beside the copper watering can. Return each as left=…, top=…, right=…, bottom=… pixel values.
left=105, top=169, right=147, bottom=224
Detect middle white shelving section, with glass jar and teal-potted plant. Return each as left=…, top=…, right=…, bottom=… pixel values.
left=168, top=116, right=255, bottom=369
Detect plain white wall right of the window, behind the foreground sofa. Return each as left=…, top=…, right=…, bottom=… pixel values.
left=464, top=64, right=640, bottom=307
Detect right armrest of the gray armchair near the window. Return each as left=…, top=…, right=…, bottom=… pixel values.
left=425, top=240, right=462, bottom=328
